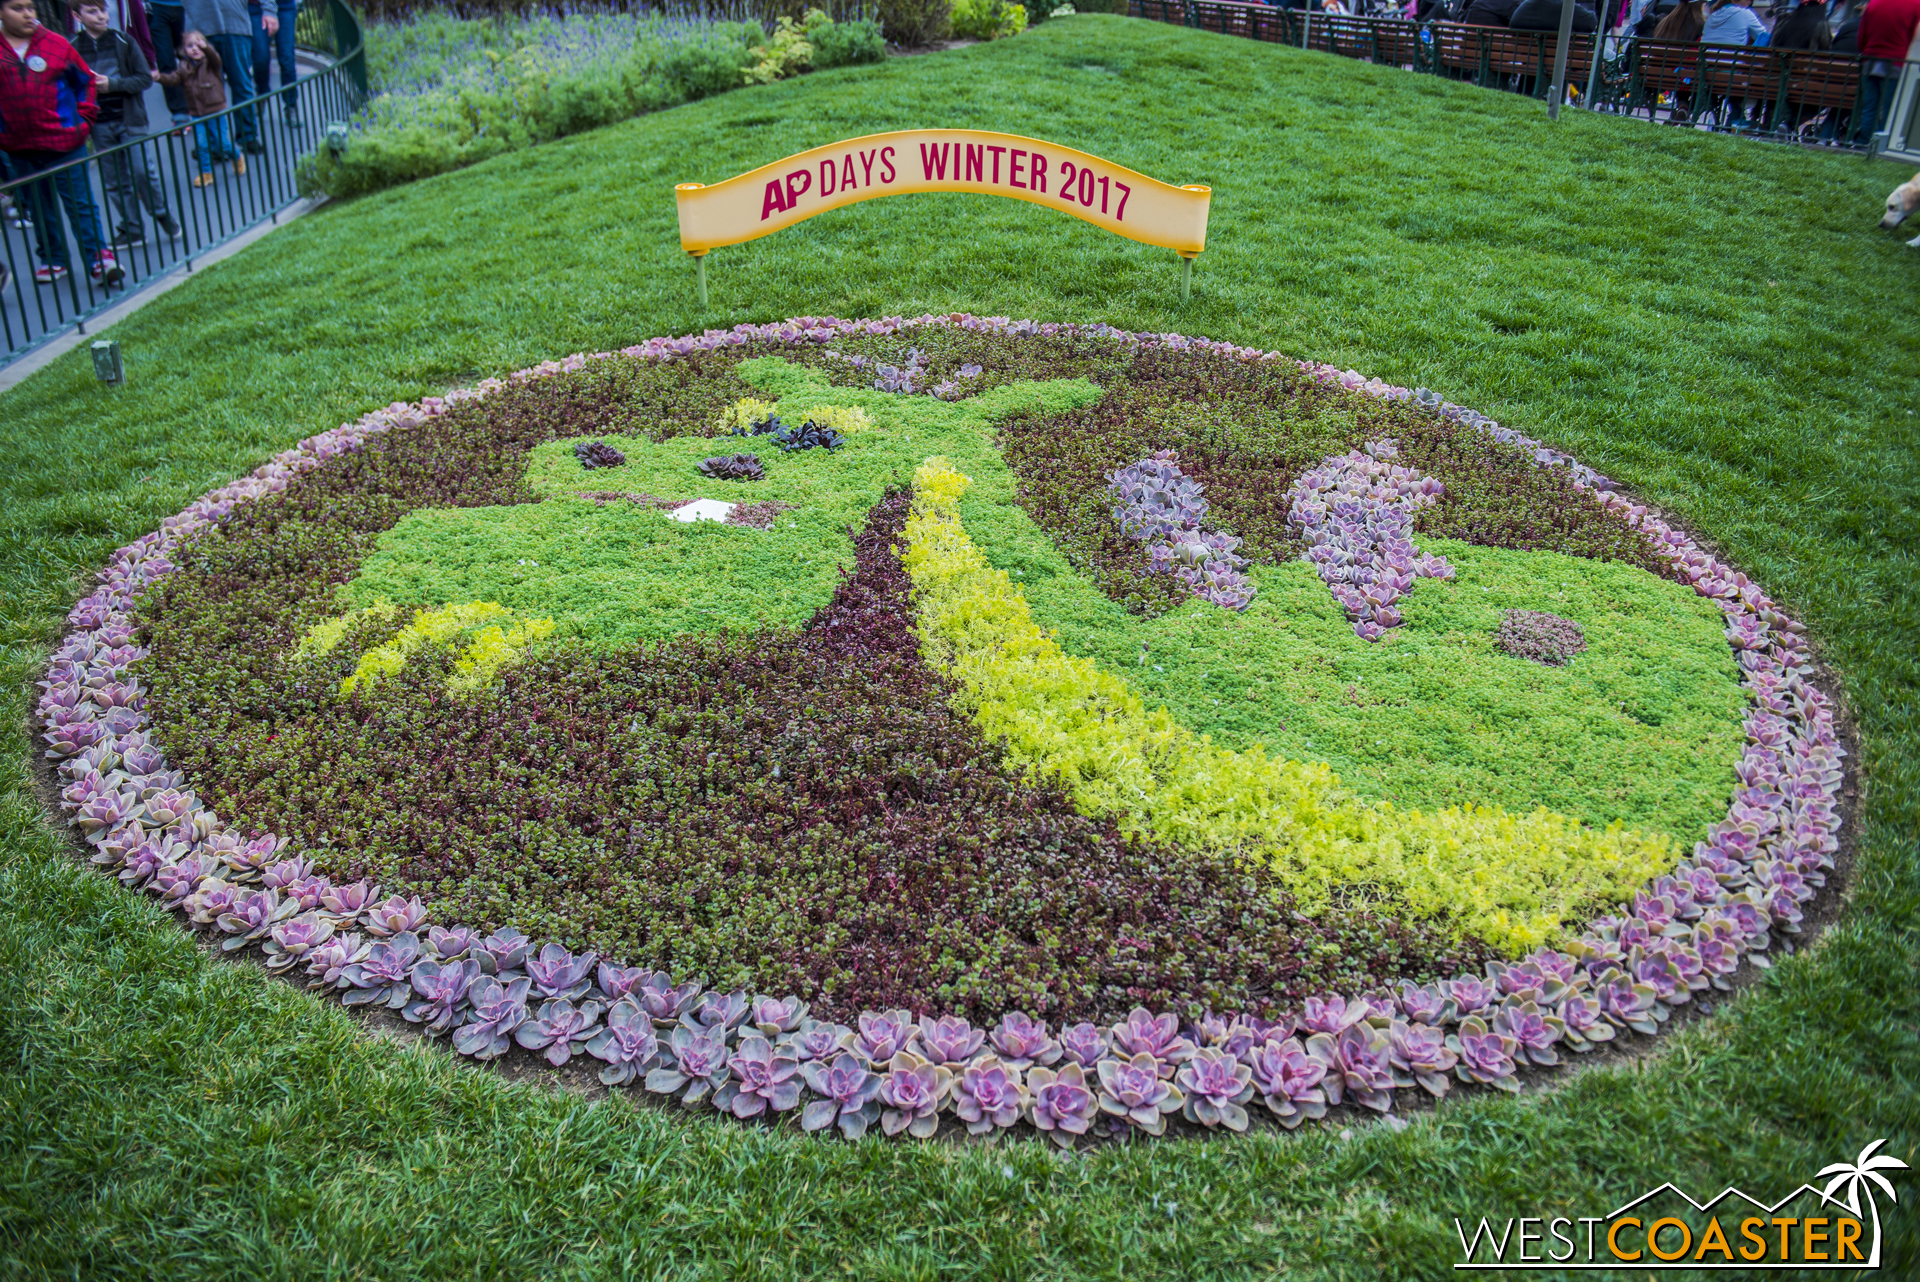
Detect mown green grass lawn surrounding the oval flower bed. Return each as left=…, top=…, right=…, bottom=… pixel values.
left=0, top=17, right=1920, bottom=1278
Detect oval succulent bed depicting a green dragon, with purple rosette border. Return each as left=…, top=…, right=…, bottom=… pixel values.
left=38, top=317, right=1843, bottom=1142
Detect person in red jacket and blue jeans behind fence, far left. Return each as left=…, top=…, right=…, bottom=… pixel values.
left=0, top=0, right=127, bottom=286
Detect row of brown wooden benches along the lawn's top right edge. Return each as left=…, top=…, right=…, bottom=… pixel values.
left=1131, top=0, right=1920, bottom=152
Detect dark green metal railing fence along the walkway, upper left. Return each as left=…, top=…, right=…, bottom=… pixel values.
left=0, top=0, right=367, bottom=365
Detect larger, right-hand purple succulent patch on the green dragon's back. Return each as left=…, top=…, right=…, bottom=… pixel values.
left=1286, top=441, right=1453, bottom=641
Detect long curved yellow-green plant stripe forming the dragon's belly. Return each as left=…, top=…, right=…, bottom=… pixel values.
left=902, top=459, right=1674, bottom=952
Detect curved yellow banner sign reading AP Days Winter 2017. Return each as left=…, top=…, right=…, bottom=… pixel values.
left=674, top=129, right=1212, bottom=259
